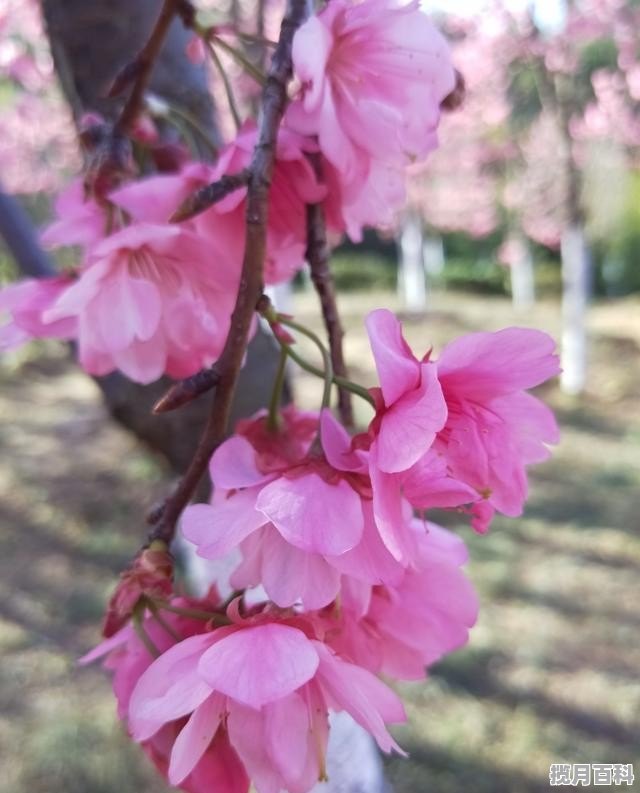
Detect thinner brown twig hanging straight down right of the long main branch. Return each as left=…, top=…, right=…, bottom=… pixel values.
left=307, top=154, right=353, bottom=427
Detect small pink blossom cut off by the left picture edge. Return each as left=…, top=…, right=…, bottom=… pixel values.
left=0, top=276, right=77, bottom=350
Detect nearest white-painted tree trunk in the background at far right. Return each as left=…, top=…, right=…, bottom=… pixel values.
left=560, top=225, right=591, bottom=394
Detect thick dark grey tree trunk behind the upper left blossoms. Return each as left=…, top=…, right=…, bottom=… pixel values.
left=33, top=0, right=278, bottom=471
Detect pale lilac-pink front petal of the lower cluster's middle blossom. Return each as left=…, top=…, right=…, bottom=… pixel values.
left=256, top=473, right=364, bottom=556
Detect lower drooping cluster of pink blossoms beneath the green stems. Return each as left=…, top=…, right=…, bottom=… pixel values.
left=85, top=309, right=558, bottom=793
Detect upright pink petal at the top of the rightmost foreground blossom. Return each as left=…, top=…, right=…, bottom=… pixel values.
left=366, top=308, right=420, bottom=407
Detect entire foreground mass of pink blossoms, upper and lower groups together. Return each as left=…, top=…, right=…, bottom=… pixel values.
left=0, top=0, right=558, bottom=793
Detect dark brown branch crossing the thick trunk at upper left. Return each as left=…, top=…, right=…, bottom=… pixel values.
left=113, top=0, right=183, bottom=136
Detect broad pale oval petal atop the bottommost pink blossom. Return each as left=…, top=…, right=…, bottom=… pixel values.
left=198, top=624, right=318, bottom=708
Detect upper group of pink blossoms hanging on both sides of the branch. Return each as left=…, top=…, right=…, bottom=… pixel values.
left=0, top=0, right=455, bottom=383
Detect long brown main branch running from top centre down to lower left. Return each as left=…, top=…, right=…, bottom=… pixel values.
left=149, top=0, right=306, bottom=543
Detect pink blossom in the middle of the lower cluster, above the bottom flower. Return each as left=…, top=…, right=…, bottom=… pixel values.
left=182, top=409, right=406, bottom=609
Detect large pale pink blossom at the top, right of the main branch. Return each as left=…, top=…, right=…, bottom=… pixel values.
left=286, top=0, right=455, bottom=238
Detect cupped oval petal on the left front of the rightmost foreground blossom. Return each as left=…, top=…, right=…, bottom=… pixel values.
left=376, top=363, right=447, bottom=473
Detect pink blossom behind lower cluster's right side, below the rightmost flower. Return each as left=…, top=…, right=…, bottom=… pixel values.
left=327, top=520, right=478, bottom=680
